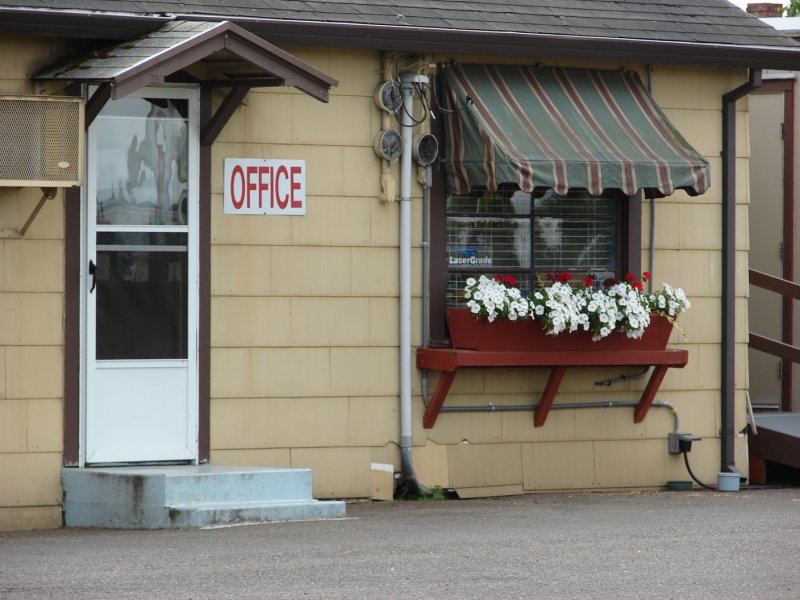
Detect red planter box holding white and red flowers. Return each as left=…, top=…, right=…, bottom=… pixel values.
left=447, top=308, right=672, bottom=351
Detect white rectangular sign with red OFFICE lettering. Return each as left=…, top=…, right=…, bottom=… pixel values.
left=223, top=158, right=306, bottom=215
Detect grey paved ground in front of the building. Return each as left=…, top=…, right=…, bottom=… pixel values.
left=0, top=488, right=800, bottom=599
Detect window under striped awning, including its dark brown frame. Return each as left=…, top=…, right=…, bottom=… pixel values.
left=428, top=164, right=642, bottom=347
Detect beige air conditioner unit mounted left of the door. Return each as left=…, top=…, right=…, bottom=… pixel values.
left=0, top=96, right=84, bottom=187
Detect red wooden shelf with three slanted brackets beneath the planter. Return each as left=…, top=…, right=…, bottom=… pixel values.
left=417, top=348, right=689, bottom=429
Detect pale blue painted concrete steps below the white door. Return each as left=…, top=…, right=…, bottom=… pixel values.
left=61, top=465, right=345, bottom=529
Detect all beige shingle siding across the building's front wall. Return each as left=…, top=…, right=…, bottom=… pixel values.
left=0, top=31, right=748, bottom=529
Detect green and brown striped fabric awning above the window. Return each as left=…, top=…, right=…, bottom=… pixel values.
left=444, top=65, right=710, bottom=196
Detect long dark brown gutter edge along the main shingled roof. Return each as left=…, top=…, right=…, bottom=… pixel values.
left=0, top=8, right=800, bottom=70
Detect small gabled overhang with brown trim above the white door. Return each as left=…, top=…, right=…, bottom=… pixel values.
left=32, top=21, right=338, bottom=102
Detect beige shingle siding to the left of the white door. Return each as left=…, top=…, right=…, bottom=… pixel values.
left=0, top=35, right=69, bottom=531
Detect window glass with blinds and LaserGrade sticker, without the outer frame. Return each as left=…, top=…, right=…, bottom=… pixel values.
left=445, top=185, right=627, bottom=305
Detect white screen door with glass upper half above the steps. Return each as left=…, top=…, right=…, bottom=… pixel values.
left=84, top=88, right=198, bottom=464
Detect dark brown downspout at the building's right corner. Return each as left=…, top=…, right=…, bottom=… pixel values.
left=720, top=69, right=761, bottom=473
